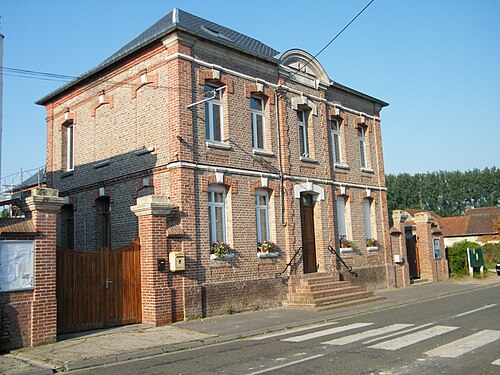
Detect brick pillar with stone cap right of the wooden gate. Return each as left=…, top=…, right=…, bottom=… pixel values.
left=130, top=195, right=172, bottom=326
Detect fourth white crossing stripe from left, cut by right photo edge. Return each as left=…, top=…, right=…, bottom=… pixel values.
left=425, top=329, right=500, bottom=358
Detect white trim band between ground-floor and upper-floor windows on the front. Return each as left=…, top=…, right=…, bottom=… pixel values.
left=167, top=161, right=387, bottom=191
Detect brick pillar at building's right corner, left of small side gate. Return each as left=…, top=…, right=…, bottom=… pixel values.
left=390, top=210, right=410, bottom=287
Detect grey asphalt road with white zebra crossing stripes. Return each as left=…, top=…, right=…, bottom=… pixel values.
left=74, top=286, right=500, bottom=375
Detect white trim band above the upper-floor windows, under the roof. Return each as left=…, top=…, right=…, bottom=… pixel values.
left=165, top=52, right=380, bottom=121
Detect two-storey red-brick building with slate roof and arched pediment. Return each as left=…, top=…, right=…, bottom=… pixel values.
left=38, top=9, right=394, bottom=330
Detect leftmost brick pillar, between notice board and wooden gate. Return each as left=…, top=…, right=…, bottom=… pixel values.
left=23, top=188, right=64, bottom=346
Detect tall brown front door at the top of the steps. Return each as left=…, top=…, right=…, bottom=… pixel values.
left=300, top=194, right=317, bottom=273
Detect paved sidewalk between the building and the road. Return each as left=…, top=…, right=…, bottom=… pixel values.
left=0, top=275, right=500, bottom=374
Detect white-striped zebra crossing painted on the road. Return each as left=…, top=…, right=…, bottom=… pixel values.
left=249, top=322, right=500, bottom=366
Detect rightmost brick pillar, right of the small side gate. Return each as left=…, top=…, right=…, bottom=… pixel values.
left=414, top=212, right=438, bottom=281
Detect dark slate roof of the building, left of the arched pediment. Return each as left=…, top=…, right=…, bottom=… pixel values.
left=36, top=8, right=279, bottom=105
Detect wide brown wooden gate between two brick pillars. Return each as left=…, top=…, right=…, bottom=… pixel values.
left=57, top=240, right=142, bottom=334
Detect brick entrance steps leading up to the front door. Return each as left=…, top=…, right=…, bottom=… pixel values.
left=283, top=273, right=384, bottom=311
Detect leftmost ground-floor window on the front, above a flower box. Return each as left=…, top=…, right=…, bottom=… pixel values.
left=208, top=186, right=226, bottom=244
